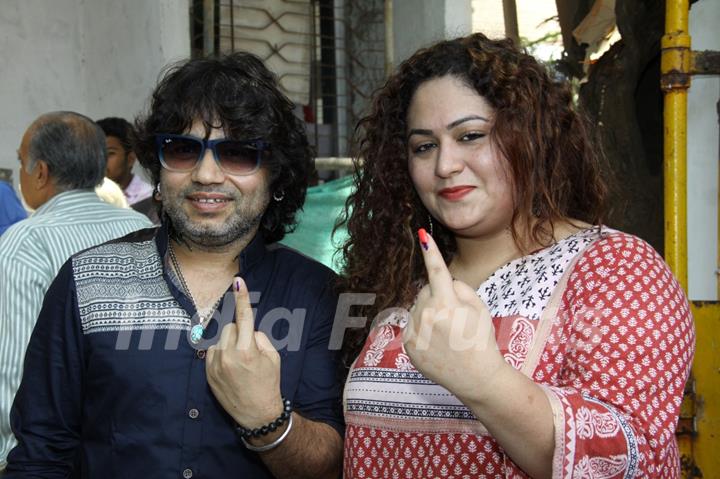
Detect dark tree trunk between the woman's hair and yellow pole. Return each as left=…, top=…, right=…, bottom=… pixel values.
left=558, top=0, right=665, bottom=251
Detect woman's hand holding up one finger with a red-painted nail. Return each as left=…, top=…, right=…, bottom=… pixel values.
left=403, top=231, right=507, bottom=400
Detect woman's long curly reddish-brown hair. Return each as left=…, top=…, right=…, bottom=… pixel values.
left=339, top=33, right=606, bottom=362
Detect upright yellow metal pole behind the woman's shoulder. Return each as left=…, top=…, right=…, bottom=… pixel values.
left=660, top=0, right=695, bottom=478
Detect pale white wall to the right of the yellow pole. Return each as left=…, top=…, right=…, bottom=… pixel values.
left=688, top=0, right=720, bottom=300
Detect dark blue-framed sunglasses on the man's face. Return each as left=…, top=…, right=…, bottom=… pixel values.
left=155, top=134, right=270, bottom=176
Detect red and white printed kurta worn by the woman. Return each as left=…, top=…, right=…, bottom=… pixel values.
left=344, top=228, right=695, bottom=479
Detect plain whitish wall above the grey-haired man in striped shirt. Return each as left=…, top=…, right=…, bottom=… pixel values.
left=0, top=0, right=190, bottom=182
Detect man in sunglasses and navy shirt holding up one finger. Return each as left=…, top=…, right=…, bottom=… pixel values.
left=4, top=53, right=343, bottom=479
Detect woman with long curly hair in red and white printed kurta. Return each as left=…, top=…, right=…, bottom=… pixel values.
left=342, top=34, right=694, bottom=478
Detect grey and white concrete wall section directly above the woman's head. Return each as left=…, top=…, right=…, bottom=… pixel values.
left=393, top=0, right=472, bottom=65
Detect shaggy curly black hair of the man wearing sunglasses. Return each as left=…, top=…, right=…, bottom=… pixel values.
left=133, top=52, right=314, bottom=243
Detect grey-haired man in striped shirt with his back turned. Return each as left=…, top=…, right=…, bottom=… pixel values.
left=0, top=111, right=152, bottom=464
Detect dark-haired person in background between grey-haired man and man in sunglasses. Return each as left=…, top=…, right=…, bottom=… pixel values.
left=96, top=117, right=159, bottom=224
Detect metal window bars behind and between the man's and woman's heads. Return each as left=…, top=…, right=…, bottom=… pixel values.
left=191, top=0, right=386, bottom=172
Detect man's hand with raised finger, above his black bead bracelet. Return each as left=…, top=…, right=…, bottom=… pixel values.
left=205, top=278, right=283, bottom=429
